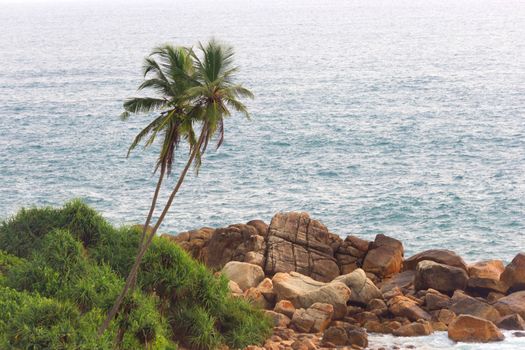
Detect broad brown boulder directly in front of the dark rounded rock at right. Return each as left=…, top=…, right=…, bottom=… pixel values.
left=414, top=260, right=468, bottom=293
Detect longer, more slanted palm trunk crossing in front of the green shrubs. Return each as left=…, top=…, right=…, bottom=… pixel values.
left=98, top=124, right=207, bottom=337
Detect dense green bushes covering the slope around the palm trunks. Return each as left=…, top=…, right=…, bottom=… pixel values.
left=0, top=201, right=270, bottom=349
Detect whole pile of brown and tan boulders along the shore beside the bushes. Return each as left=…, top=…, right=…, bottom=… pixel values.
left=163, top=212, right=525, bottom=350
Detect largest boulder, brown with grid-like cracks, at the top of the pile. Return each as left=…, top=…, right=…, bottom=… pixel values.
left=264, top=212, right=342, bottom=282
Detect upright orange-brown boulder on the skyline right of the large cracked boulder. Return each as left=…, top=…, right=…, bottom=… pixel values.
left=363, top=234, right=404, bottom=278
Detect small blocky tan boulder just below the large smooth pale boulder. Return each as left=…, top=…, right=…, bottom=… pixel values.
left=291, top=303, right=334, bottom=333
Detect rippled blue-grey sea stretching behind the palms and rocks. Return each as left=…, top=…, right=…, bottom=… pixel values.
left=0, top=0, right=525, bottom=261
